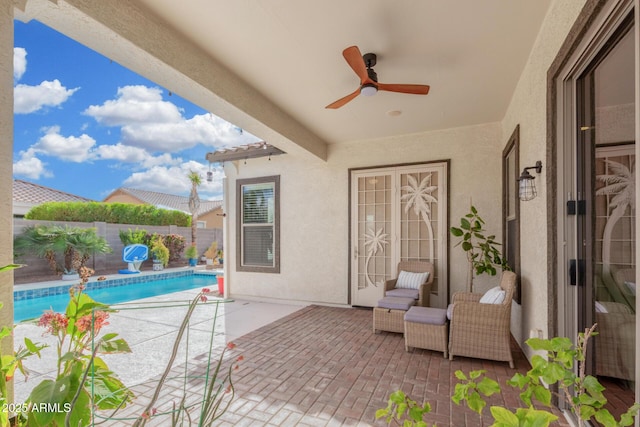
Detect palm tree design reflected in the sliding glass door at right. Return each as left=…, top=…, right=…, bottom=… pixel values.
left=596, top=160, right=636, bottom=278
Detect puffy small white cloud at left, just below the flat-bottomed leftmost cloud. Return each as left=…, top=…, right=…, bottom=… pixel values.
left=31, top=126, right=96, bottom=163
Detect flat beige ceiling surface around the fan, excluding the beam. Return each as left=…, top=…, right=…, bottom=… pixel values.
left=132, top=0, right=550, bottom=144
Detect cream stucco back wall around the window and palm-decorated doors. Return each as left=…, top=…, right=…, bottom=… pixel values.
left=225, top=123, right=503, bottom=304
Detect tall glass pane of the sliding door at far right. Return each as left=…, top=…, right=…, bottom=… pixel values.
left=592, top=22, right=636, bottom=417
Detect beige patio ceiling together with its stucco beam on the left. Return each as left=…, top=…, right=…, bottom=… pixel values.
left=16, top=0, right=550, bottom=159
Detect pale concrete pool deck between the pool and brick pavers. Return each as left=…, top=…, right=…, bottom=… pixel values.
left=14, top=281, right=304, bottom=414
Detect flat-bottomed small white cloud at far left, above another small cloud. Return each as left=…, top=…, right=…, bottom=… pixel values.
left=13, top=79, right=79, bottom=114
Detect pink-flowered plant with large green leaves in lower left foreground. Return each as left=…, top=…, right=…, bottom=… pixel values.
left=21, top=267, right=133, bottom=426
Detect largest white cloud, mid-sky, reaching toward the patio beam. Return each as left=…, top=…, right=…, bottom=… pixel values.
left=84, top=86, right=258, bottom=152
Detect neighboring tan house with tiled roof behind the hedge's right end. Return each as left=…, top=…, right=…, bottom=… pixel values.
left=103, top=187, right=223, bottom=228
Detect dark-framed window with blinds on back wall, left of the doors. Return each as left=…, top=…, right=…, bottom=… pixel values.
left=236, top=176, right=280, bottom=273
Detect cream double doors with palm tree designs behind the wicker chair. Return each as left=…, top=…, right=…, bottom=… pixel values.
left=351, top=162, right=448, bottom=307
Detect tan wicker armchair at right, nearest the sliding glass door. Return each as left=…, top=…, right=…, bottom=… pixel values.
left=449, top=271, right=516, bottom=368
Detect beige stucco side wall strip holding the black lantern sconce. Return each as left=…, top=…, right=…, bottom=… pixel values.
left=501, top=0, right=585, bottom=351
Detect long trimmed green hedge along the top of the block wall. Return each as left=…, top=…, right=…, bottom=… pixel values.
left=25, top=202, right=191, bottom=227
